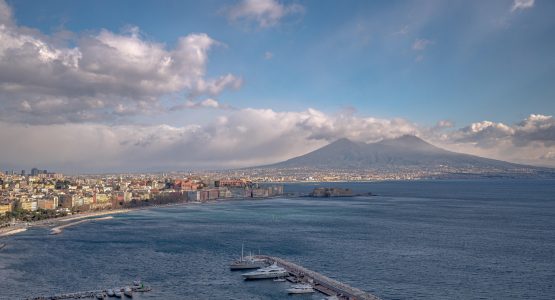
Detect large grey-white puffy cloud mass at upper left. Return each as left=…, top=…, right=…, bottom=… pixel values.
left=0, top=0, right=243, bottom=124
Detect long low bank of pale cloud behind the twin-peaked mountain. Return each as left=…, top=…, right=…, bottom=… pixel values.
left=0, top=108, right=555, bottom=173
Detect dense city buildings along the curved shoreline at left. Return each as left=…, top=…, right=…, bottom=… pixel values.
left=0, top=168, right=283, bottom=227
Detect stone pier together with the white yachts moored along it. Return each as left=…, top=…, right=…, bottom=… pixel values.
left=237, top=255, right=380, bottom=300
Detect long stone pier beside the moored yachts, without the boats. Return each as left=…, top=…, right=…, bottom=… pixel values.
left=256, top=255, right=380, bottom=300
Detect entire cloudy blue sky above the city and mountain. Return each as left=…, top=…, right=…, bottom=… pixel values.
left=0, top=0, right=555, bottom=173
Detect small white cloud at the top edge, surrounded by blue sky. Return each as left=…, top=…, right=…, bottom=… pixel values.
left=224, top=0, right=304, bottom=28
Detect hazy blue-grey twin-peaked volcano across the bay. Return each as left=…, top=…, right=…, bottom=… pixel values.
left=260, top=135, right=542, bottom=173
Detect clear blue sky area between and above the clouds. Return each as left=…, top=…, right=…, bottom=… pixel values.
left=9, top=1, right=555, bottom=125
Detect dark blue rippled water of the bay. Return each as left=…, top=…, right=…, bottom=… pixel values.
left=0, top=180, right=555, bottom=299
